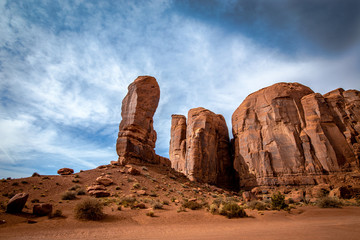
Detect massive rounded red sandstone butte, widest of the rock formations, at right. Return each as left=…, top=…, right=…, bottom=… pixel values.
left=232, top=83, right=360, bottom=187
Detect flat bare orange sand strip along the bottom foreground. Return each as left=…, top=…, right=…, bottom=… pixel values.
left=0, top=207, right=360, bottom=240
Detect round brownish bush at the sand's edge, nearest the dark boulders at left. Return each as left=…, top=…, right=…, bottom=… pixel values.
left=75, top=198, right=105, bottom=221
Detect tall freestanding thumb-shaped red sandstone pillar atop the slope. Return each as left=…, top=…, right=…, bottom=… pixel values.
left=116, top=76, right=170, bottom=165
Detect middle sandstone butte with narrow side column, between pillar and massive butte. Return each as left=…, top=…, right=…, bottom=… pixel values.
left=169, top=108, right=235, bottom=187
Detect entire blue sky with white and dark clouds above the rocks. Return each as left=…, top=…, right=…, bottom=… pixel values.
left=0, top=0, right=360, bottom=178
